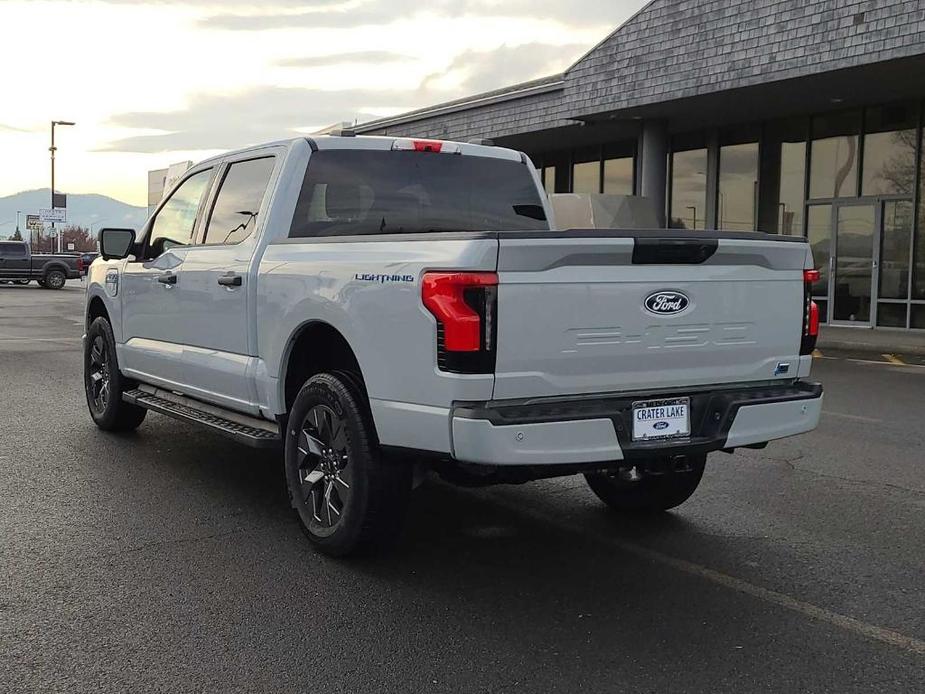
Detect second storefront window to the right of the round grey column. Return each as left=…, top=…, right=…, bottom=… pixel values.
left=717, top=142, right=758, bottom=231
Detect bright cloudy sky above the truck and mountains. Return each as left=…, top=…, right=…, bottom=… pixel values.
left=0, top=0, right=645, bottom=205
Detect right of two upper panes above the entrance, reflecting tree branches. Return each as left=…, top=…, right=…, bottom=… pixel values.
left=861, top=104, right=918, bottom=195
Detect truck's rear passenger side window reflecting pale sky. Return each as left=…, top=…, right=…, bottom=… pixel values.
left=205, top=157, right=275, bottom=245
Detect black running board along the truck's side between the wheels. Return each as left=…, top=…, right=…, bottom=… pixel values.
left=122, top=385, right=281, bottom=448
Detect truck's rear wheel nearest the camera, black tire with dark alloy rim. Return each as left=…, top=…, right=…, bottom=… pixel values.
left=285, top=373, right=411, bottom=556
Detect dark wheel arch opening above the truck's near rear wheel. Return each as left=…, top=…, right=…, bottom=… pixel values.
left=279, top=320, right=369, bottom=413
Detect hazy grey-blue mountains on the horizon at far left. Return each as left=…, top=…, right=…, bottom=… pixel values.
left=0, top=188, right=148, bottom=238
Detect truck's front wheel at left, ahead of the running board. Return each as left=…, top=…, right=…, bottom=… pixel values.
left=84, top=317, right=148, bottom=431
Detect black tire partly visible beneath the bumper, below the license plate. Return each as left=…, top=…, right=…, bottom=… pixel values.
left=585, top=455, right=707, bottom=513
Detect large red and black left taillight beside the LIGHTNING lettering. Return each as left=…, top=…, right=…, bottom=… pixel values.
left=421, top=272, right=498, bottom=373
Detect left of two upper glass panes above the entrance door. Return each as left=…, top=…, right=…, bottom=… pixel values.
left=809, top=112, right=861, bottom=198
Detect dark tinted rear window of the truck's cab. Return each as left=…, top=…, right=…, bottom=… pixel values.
left=289, top=149, right=549, bottom=238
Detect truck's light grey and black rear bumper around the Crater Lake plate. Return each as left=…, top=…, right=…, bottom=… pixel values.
left=451, top=381, right=822, bottom=465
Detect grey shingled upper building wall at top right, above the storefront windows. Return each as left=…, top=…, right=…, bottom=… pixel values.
left=566, top=0, right=925, bottom=114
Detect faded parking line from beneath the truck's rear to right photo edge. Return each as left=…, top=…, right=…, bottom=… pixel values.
left=492, top=495, right=925, bottom=655
